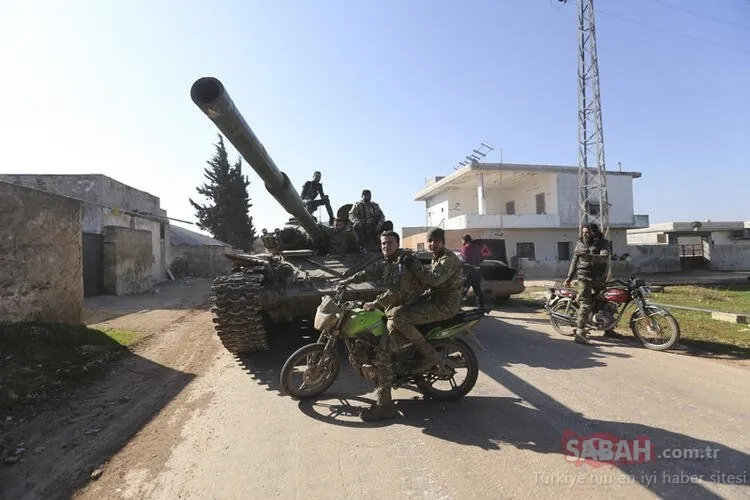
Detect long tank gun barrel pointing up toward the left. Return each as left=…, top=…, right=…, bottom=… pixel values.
left=190, top=77, right=325, bottom=246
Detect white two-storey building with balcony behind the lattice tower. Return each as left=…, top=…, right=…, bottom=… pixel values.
left=403, top=163, right=649, bottom=270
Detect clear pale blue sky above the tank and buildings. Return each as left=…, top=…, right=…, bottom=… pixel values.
left=0, top=0, right=750, bottom=236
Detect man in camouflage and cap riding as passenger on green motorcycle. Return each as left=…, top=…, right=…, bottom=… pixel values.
left=396, top=227, right=463, bottom=373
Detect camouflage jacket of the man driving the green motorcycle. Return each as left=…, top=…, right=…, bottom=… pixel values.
left=348, top=249, right=426, bottom=309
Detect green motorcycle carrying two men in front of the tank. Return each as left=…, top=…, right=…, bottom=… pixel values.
left=280, top=288, right=484, bottom=401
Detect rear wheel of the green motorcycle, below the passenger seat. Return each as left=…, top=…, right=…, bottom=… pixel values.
left=414, top=339, right=479, bottom=401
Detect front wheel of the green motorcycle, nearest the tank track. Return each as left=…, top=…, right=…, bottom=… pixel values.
left=279, top=343, right=341, bottom=399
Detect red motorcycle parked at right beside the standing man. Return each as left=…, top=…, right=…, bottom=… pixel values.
left=544, top=276, right=680, bottom=351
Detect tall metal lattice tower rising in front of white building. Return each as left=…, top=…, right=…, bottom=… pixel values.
left=576, top=0, right=609, bottom=239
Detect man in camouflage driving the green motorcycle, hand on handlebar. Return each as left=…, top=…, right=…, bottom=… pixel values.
left=339, top=231, right=434, bottom=422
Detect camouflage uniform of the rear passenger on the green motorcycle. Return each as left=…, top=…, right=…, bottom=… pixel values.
left=396, top=250, right=463, bottom=347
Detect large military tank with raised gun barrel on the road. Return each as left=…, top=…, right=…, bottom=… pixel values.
left=190, top=77, right=392, bottom=354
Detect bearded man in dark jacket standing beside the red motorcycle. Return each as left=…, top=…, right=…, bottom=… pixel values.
left=565, top=222, right=610, bottom=344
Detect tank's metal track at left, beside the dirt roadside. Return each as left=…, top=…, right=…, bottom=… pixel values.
left=211, top=265, right=269, bottom=354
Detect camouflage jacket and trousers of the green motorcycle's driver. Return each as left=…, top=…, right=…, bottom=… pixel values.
left=347, top=249, right=425, bottom=414
